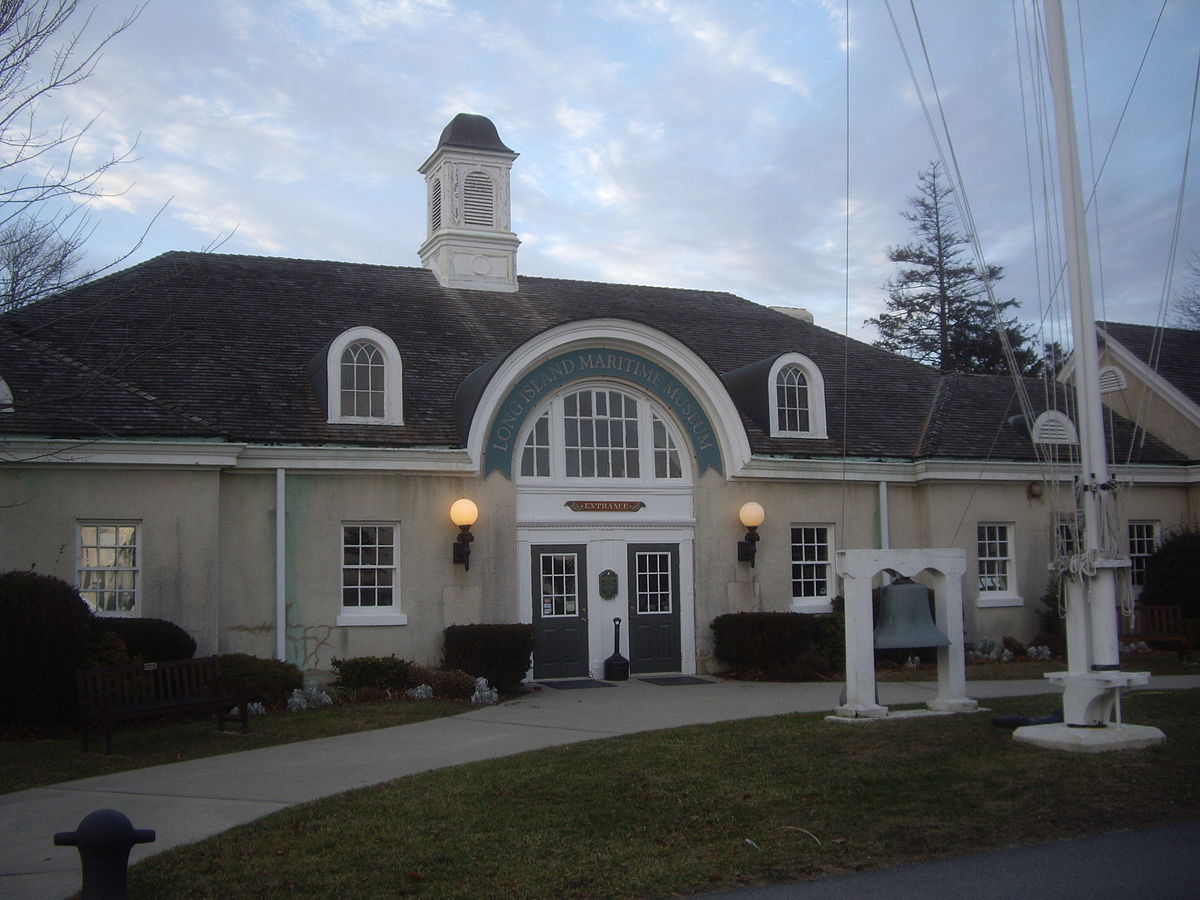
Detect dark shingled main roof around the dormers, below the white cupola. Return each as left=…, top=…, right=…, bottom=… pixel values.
left=0, top=252, right=1181, bottom=462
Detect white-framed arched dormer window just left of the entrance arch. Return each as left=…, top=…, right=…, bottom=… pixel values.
left=325, top=325, right=404, bottom=425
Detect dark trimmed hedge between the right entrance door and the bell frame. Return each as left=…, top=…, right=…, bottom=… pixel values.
left=712, top=610, right=845, bottom=680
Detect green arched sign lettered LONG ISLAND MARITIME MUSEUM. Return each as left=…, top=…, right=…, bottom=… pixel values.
left=484, top=347, right=724, bottom=478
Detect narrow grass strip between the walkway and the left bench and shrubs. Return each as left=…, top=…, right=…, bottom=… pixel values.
left=0, top=700, right=472, bottom=793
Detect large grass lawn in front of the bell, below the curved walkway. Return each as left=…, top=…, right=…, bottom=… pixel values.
left=130, top=690, right=1200, bottom=900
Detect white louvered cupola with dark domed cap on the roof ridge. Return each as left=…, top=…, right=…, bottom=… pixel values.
left=418, top=113, right=521, bottom=292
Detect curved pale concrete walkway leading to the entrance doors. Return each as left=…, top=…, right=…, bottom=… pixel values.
left=0, top=676, right=1200, bottom=900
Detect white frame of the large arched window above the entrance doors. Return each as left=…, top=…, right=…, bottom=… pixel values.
left=514, top=380, right=692, bottom=490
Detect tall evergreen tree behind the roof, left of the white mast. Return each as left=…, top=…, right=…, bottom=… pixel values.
left=866, top=162, right=1040, bottom=373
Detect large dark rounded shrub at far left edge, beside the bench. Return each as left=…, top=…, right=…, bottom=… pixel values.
left=0, top=571, right=92, bottom=725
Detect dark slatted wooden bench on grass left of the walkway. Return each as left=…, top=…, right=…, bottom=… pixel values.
left=76, top=656, right=250, bottom=755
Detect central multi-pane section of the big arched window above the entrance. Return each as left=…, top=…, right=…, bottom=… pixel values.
left=563, top=389, right=641, bottom=478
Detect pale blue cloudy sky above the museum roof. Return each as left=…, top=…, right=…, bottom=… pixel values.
left=35, top=0, right=1200, bottom=340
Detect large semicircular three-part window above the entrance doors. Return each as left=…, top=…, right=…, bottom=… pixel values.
left=521, top=385, right=684, bottom=481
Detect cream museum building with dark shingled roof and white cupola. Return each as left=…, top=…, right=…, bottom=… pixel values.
left=0, top=115, right=1200, bottom=678
